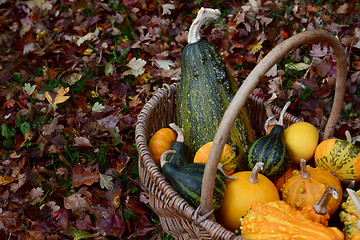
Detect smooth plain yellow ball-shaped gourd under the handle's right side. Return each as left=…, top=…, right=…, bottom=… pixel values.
left=284, top=122, right=319, bottom=164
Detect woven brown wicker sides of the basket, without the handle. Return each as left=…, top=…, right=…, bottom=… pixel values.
left=135, top=83, right=301, bottom=239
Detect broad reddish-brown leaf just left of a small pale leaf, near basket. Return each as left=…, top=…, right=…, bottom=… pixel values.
left=72, top=165, right=100, bottom=188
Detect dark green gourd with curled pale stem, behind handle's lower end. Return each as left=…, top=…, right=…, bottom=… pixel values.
left=160, top=150, right=226, bottom=210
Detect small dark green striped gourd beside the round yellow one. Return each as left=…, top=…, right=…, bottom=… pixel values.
left=247, top=102, right=292, bottom=179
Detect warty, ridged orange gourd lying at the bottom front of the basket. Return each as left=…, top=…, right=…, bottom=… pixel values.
left=237, top=201, right=344, bottom=240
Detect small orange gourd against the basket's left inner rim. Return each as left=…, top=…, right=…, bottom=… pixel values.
left=149, top=128, right=176, bottom=164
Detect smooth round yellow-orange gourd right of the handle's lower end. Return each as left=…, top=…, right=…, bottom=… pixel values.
left=215, top=162, right=280, bottom=231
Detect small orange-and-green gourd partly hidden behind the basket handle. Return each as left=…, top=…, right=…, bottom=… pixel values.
left=194, top=142, right=237, bottom=175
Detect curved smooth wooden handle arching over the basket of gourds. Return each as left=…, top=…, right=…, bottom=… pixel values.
left=200, top=29, right=347, bottom=215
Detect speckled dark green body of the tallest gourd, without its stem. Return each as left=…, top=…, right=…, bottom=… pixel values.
left=177, top=40, right=256, bottom=169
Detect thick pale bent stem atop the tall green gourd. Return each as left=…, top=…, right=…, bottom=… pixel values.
left=188, top=7, right=221, bottom=44
